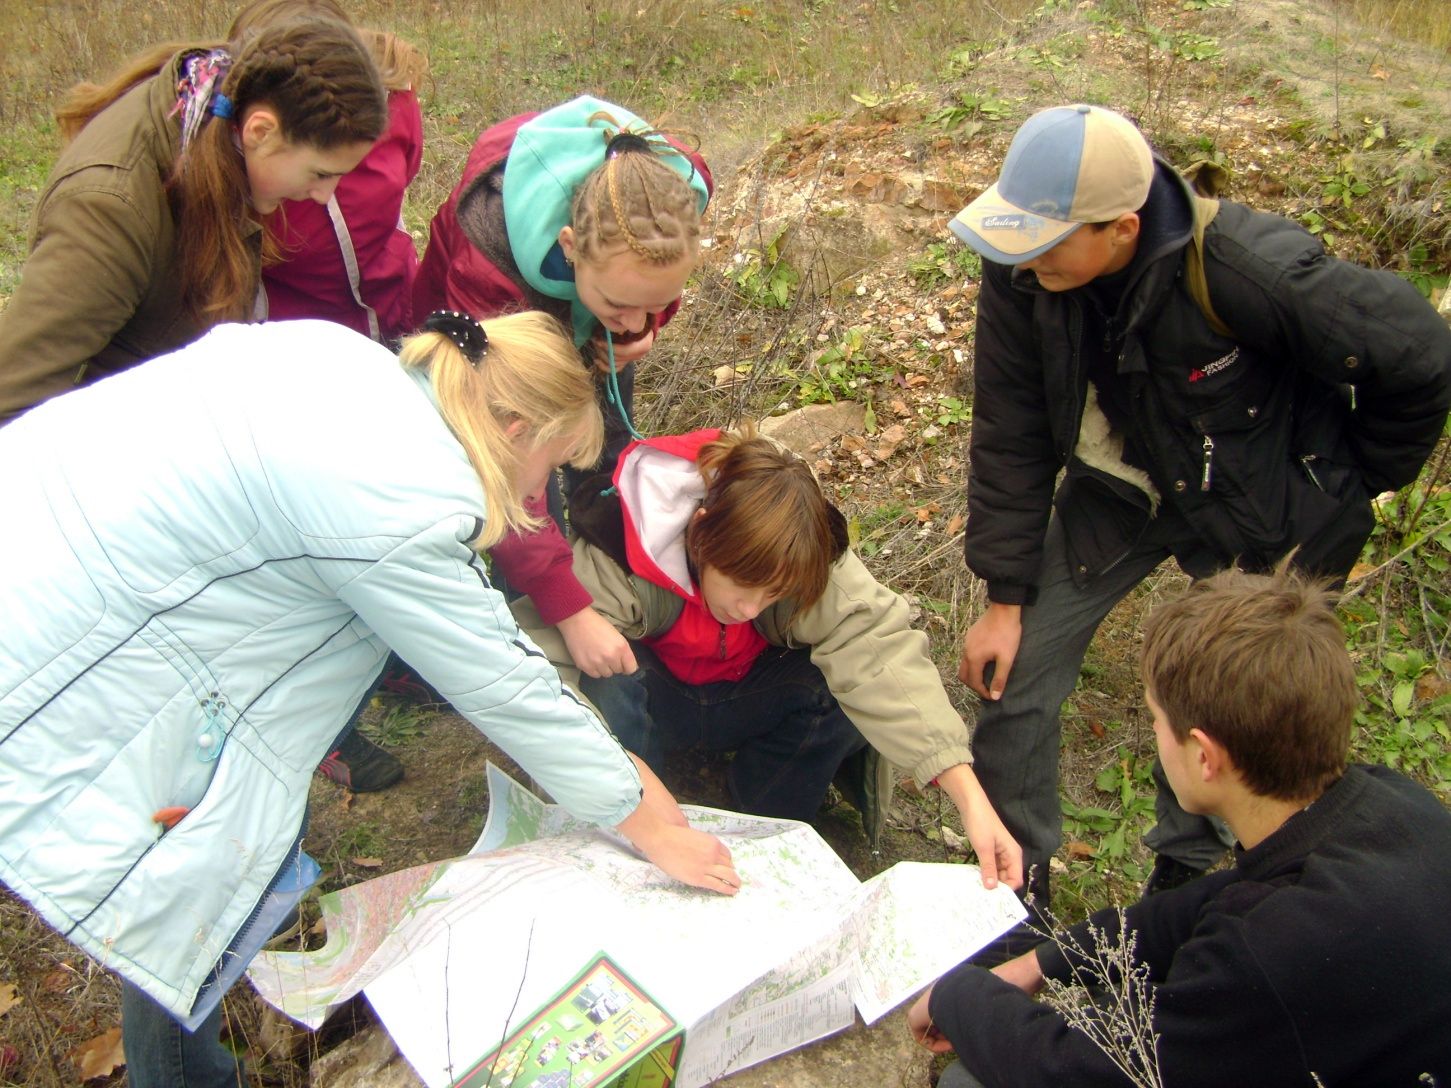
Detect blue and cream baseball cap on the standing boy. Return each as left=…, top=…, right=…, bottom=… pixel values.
left=948, top=106, right=1154, bottom=264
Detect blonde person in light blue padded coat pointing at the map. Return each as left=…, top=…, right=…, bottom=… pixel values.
left=0, top=313, right=739, bottom=1088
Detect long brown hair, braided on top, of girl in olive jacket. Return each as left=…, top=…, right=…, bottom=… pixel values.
left=168, top=19, right=387, bottom=328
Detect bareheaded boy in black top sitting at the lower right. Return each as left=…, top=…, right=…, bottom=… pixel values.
left=908, top=567, right=1451, bottom=1088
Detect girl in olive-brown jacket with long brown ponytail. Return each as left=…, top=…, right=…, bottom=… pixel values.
left=0, top=20, right=387, bottom=425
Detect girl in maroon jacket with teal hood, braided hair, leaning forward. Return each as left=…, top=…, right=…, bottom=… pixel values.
left=414, top=96, right=711, bottom=699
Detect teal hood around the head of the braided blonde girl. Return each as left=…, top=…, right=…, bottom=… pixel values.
left=503, top=94, right=710, bottom=347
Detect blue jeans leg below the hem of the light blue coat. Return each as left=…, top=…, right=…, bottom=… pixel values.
left=120, top=982, right=247, bottom=1088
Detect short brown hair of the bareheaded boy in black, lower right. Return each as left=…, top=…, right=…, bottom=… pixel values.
left=1143, top=564, right=1360, bottom=801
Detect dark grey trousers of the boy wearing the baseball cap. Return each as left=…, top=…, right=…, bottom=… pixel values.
left=972, top=515, right=1232, bottom=873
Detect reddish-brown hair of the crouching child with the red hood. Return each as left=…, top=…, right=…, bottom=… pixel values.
left=685, top=424, right=846, bottom=611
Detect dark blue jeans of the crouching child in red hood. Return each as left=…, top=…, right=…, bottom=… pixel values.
left=580, top=643, right=866, bottom=821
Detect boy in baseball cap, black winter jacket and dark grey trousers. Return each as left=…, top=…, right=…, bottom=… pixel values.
left=952, top=106, right=1451, bottom=907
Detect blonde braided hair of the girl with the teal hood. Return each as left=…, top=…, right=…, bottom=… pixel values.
left=570, top=141, right=701, bottom=265
